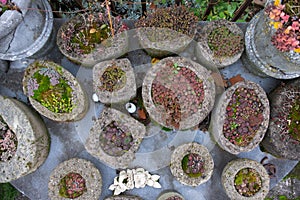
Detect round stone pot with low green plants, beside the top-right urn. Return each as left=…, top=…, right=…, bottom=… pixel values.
left=196, top=20, right=244, bottom=68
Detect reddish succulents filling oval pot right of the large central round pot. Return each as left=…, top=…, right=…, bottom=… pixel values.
left=223, top=87, right=264, bottom=146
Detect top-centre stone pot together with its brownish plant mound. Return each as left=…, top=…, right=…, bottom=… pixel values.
left=135, top=6, right=198, bottom=57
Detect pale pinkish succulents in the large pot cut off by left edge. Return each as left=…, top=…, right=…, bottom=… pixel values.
left=0, top=115, right=18, bottom=162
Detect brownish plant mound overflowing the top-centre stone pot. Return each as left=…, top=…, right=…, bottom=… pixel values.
left=135, top=6, right=198, bottom=37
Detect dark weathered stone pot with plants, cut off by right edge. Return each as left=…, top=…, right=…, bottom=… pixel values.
left=262, top=78, right=300, bottom=160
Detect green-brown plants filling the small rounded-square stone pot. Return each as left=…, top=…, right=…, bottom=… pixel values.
left=99, top=66, right=127, bottom=92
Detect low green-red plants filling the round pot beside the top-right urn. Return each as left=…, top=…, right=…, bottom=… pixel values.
left=207, top=26, right=244, bottom=57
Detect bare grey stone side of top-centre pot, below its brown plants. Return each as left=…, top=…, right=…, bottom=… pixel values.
left=136, top=27, right=193, bottom=57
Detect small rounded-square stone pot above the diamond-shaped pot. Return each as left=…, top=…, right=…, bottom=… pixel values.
left=93, top=58, right=136, bottom=104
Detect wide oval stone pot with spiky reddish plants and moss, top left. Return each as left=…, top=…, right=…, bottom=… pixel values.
left=57, top=13, right=128, bottom=67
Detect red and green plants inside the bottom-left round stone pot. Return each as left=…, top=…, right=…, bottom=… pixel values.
left=59, top=172, right=87, bottom=199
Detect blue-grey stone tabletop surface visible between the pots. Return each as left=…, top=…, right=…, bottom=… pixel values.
left=0, top=19, right=297, bottom=200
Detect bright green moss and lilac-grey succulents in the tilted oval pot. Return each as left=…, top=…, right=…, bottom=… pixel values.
left=27, top=63, right=74, bottom=113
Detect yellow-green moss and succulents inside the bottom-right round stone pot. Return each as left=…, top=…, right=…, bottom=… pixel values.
left=234, top=168, right=262, bottom=197
